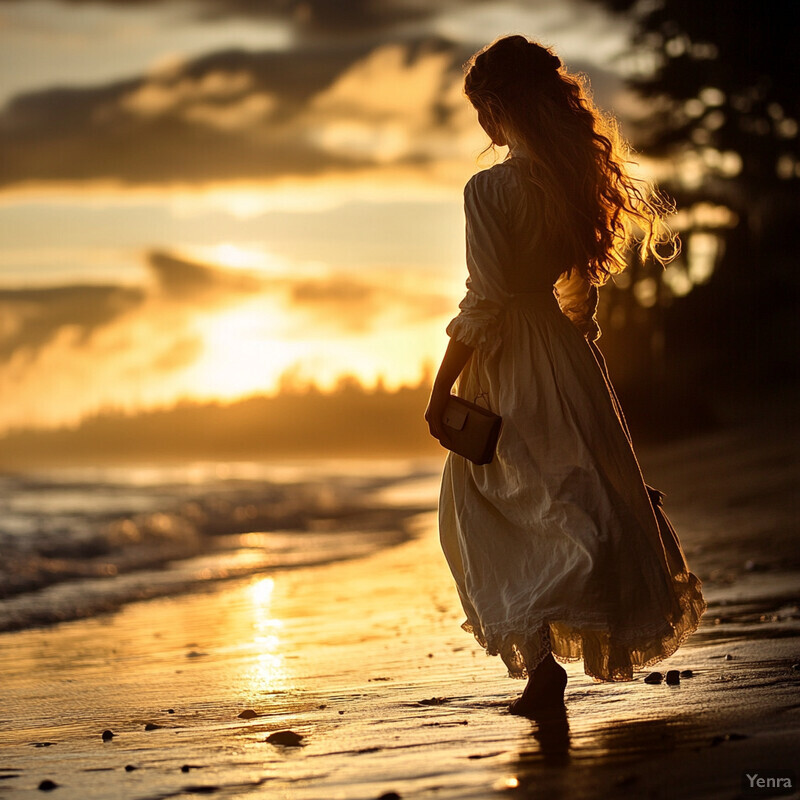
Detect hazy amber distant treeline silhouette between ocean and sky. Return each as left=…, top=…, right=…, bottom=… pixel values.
left=0, top=379, right=441, bottom=470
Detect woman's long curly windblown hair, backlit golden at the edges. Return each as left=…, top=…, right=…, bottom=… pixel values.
left=464, top=36, right=679, bottom=286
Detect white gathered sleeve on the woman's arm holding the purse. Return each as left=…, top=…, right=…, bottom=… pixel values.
left=447, top=169, right=511, bottom=351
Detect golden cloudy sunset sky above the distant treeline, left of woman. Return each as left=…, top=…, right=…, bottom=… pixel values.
left=0, top=0, right=629, bottom=432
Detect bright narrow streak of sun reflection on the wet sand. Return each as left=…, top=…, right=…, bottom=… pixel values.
left=245, top=578, right=289, bottom=695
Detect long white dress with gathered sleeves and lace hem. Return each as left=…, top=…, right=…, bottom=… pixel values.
left=439, top=157, right=706, bottom=680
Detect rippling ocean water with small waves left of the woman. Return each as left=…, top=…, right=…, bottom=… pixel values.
left=0, top=459, right=441, bottom=632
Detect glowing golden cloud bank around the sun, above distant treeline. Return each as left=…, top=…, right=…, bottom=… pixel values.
left=0, top=252, right=454, bottom=431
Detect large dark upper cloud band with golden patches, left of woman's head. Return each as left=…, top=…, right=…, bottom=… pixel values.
left=0, top=39, right=476, bottom=186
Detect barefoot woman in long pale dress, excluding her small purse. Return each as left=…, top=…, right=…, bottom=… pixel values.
left=425, top=36, right=706, bottom=716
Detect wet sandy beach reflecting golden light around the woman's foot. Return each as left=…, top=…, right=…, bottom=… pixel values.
left=0, top=412, right=800, bottom=800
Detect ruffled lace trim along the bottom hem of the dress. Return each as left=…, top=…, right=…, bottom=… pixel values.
left=461, top=572, right=707, bottom=681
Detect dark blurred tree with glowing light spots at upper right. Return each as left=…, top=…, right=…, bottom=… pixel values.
left=598, top=0, right=800, bottom=412
